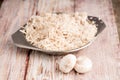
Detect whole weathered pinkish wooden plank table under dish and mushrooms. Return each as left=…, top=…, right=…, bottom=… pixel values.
left=0, top=0, right=120, bottom=80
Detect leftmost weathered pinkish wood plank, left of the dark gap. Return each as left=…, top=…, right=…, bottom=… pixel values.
left=0, top=0, right=35, bottom=80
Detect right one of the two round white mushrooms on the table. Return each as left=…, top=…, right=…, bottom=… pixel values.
left=74, top=56, right=92, bottom=73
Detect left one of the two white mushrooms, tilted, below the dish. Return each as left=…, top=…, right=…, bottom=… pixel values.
left=59, top=54, right=76, bottom=73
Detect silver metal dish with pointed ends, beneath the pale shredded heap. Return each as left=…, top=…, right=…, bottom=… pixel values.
left=12, top=16, right=106, bottom=55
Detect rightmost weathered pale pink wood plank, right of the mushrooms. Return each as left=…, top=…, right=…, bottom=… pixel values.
left=75, top=0, right=120, bottom=80
